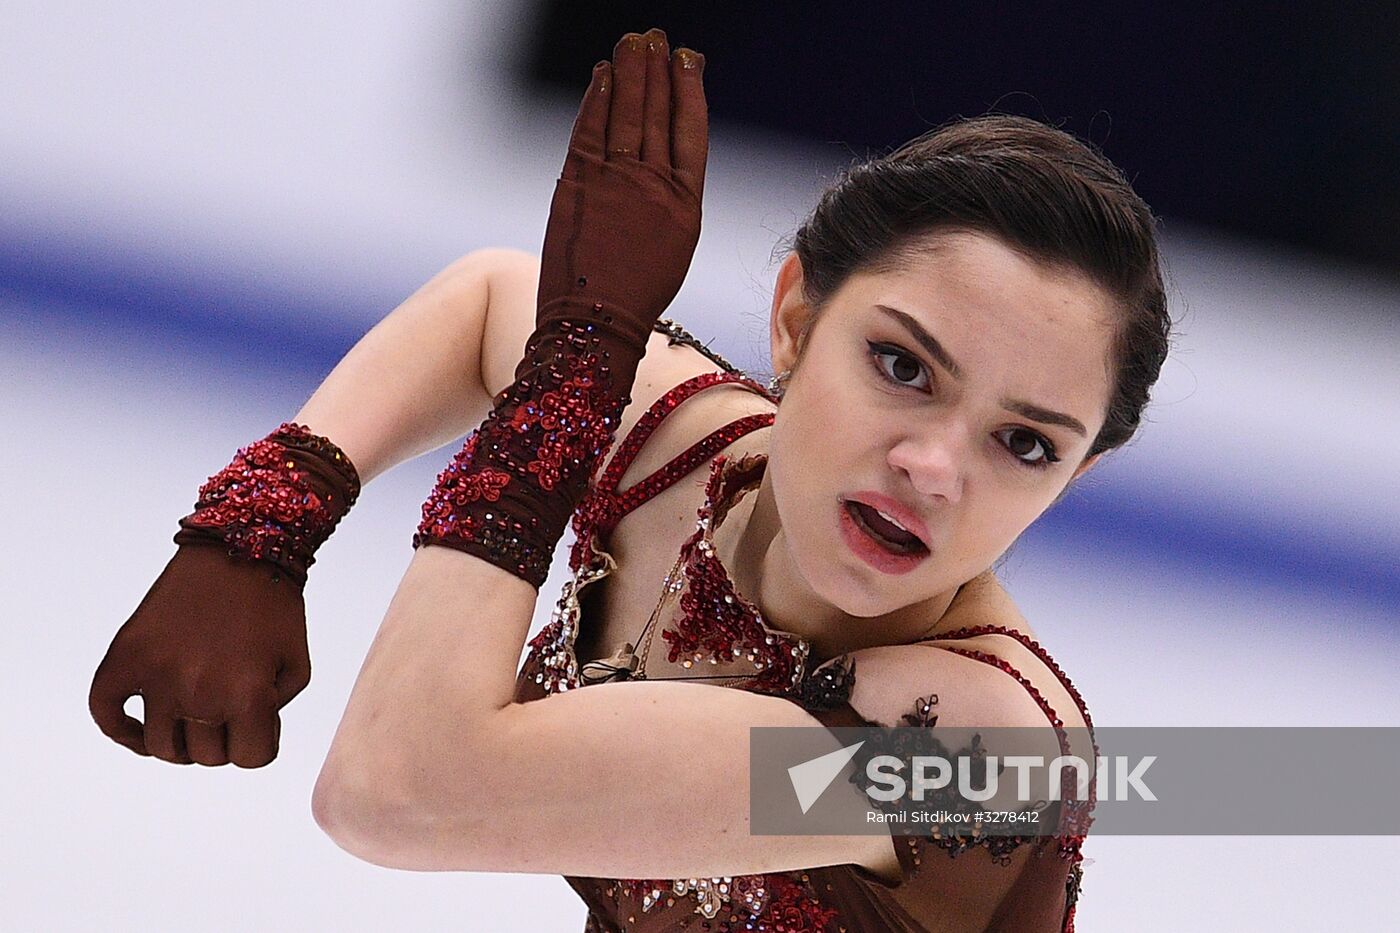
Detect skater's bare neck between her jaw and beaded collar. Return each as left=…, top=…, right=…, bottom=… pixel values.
left=715, top=456, right=956, bottom=664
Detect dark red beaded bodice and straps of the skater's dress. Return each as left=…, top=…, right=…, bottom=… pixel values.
left=517, top=325, right=1092, bottom=933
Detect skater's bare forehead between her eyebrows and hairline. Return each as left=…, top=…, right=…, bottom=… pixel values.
left=834, top=233, right=1117, bottom=402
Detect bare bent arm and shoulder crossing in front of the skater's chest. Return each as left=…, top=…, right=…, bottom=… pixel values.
left=312, top=548, right=1046, bottom=884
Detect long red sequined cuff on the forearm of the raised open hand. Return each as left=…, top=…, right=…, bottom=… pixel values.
left=413, top=303, right=648, bottom=590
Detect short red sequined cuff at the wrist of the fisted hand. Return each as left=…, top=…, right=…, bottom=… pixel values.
left=175, top=422, right=360, bottom=584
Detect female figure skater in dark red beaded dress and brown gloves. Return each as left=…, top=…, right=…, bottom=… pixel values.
left=91, top=31, right=1169, bottom=932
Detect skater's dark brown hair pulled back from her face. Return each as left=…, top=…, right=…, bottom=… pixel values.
left=792, top=116, right=1172, bottom=455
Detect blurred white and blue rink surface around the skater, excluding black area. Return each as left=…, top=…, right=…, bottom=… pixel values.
left=0, top=3, right=1400, bottom=933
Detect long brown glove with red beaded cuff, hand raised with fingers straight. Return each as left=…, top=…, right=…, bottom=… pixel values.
left=413, top=29, right=707, bottom=588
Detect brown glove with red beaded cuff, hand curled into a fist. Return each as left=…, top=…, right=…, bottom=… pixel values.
left=88, top=424, right=360, bottom=768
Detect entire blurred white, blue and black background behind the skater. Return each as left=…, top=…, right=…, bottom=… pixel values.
left=0, top=0, right=1400, bottom=933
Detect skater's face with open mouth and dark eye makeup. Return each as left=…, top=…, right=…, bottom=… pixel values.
left=769, top=233, right=1116, bottom=616
